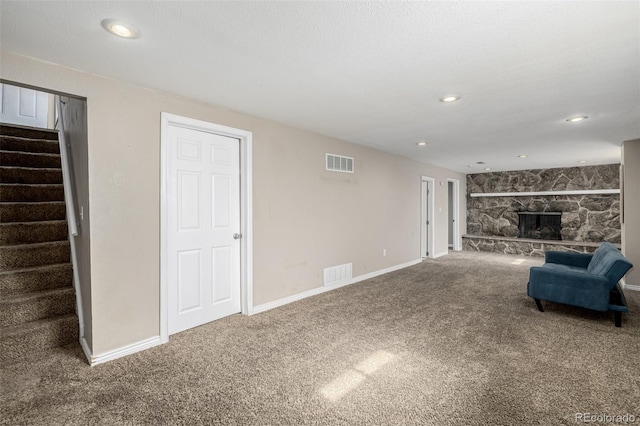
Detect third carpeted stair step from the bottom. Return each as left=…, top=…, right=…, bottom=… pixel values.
left=0, top=263, right=73, bottom=297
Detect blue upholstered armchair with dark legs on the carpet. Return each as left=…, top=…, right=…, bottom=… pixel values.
left=527, top=243, right=633, bottom=327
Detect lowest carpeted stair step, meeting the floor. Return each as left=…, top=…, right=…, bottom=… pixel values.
left=0, top=315, right=78, bottom=365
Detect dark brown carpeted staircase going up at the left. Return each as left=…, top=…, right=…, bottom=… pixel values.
left=0, top=125, right=78, bottom=364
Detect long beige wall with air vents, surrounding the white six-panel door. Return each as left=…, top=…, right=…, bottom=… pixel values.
left=0, top=52, right=466, bottom=356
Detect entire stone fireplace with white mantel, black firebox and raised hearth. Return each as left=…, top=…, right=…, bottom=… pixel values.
left=463, top=164, right=621, bottom=256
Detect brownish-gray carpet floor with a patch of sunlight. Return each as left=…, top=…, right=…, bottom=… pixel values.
left=0, top=252, right=640, bottom=425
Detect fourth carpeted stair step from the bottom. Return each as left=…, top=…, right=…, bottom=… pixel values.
left=0, top=241, right=71, bottom=271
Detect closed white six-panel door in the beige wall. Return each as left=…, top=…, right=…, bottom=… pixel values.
left=167, top=125, right=240, bottom=334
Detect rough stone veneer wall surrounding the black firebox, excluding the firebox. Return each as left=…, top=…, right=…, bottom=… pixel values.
left=467, top=164, right=621, bottom=243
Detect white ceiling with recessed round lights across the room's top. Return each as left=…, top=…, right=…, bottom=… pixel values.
left=0, top=1, right=640, bottom=173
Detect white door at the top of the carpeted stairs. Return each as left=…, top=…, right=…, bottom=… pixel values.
left=0, top=84, right=49, bottom=129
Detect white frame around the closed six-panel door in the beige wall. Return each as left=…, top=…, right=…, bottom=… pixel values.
left=160, top=112, right=253, bottom=343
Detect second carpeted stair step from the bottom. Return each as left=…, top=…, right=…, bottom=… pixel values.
left=0, top=287, right=76, bottom=327
